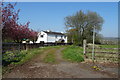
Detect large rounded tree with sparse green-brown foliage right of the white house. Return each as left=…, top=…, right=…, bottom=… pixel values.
left=65, top=11, right=103, bottom=45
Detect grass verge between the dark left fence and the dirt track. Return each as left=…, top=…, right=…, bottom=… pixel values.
left=2, top=46, right=56, bottom=74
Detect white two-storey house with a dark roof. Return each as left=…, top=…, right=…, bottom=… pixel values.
left=36, top=30, right=67, bottom=43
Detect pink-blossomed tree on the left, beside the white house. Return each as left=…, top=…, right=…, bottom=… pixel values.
left=2, top=3, right=37, bottom=42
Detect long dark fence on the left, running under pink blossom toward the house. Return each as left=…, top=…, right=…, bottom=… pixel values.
left=2, top=43, right=72, bottom=53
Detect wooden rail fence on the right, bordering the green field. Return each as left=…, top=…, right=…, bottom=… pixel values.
left=85, top=47, right=120, bottom=63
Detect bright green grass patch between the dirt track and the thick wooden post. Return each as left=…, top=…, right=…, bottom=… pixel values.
left=62, top=46, right=84, bottom=62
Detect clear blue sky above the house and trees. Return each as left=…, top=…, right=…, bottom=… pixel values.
left=9, top=2, right=118, bottom=37
